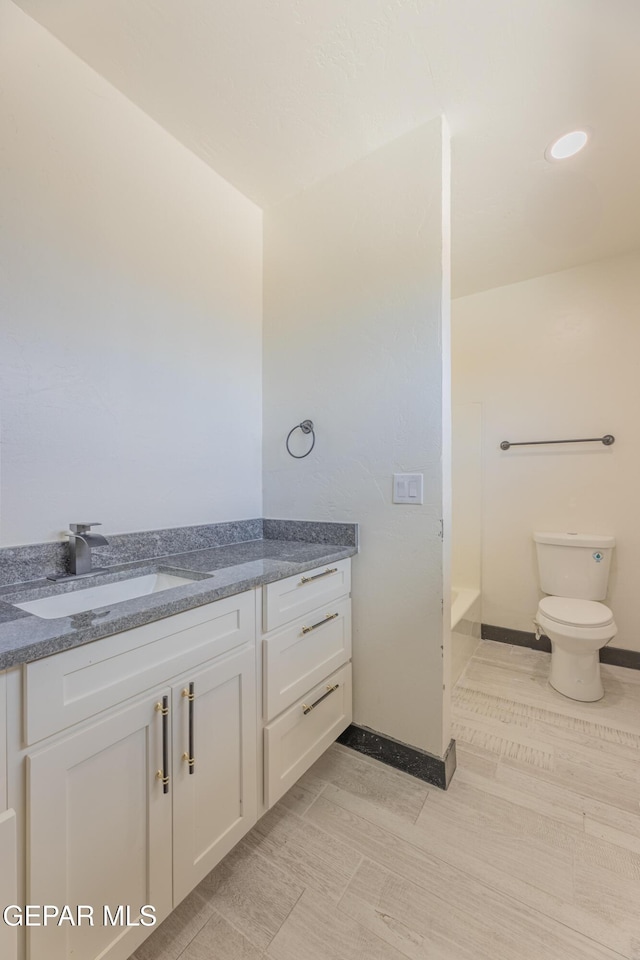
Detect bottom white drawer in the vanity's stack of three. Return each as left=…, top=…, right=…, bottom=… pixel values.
left=264, top=663, right=352, bottom=807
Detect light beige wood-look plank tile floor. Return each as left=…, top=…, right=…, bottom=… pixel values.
left=134, top=641, right=640, bottom=960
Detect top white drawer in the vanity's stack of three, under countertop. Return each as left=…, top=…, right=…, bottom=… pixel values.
left=262, top=558, right=351, bottom=633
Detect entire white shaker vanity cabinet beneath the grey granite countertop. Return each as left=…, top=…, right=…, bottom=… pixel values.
left=0, top=560, right=351, bottom=960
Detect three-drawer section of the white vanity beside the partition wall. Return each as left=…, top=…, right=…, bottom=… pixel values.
left=262, top=560, right=352, bottom=808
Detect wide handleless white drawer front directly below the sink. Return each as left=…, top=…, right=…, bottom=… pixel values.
left=24, top=591, right=255, bottom=745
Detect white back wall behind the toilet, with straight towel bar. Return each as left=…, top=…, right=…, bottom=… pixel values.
left=452, top=253, right=640, bottom=650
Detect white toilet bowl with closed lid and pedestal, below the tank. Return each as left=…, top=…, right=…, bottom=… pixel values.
left=535, top=596, right=618, bottom=701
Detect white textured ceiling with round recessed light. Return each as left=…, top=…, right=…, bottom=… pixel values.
left=10, top=0, right=640, bottom=296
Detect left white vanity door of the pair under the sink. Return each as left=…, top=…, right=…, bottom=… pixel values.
left=27, top=687, right=173, bottom=960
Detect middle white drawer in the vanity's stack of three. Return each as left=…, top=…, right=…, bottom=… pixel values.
left=263, top=598, right=351, bottom=720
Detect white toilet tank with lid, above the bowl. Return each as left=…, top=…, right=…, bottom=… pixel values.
left=533, top=533, right=616, bottom=600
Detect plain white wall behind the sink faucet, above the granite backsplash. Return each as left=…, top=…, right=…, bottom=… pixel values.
left=0, top=0, right=262, bottom=545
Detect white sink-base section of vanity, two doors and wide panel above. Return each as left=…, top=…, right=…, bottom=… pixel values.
left=16, top=593, right=257, bottom=960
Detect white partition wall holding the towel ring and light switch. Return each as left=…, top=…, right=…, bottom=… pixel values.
left=264, top=120, right=449, bottom=756
